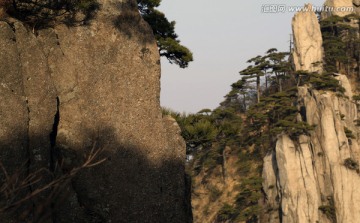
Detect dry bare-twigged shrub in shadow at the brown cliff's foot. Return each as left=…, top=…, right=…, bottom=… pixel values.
left=0, top=146, right=106, bottom=222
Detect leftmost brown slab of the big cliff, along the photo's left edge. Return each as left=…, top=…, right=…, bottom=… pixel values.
left=0, top=22, right=29, bottom=173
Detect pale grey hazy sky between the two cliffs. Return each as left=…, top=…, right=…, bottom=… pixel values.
left=159, top=0, right=324, bottom=112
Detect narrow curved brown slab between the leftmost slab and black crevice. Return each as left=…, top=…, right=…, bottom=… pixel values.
left=13, top=22, right=57, bottom=181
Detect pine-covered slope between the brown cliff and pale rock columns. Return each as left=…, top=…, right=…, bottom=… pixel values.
left=167, top=33, right=355, bottom=223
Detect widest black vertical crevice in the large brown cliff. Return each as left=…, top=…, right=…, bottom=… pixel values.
left=50, top=97, right=60, bottom=172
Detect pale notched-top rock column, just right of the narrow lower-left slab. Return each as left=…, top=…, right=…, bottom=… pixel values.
left=276, top=135, right=320, bottom=222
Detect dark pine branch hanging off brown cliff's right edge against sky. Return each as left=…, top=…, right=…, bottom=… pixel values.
left=138, top=0, right=193, bottom=68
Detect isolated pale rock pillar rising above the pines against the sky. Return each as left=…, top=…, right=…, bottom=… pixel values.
left=292, top=4, right=323, bottom=72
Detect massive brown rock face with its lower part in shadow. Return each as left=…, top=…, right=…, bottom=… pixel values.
left=0, top=1, right=191, bottom=222
